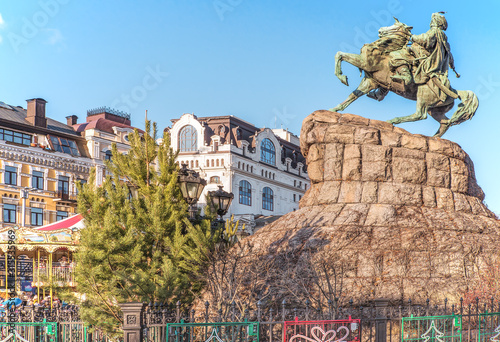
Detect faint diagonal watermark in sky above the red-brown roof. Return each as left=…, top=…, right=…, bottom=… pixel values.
left=111, top=65, right=169, bottom=113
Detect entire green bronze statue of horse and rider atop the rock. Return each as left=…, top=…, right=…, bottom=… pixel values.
left=330, top=12, right=479, bottom=137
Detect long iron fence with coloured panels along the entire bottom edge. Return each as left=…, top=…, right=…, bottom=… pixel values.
left=0, top=299, right=500, bottom=342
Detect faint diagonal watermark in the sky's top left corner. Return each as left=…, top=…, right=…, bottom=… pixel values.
left=7, top=0, right=70, bottom=53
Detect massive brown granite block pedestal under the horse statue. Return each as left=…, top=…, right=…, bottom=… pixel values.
left=227, top=110, right=500, bottom=302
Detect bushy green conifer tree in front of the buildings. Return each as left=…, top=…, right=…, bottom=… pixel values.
left=75, top=121, right=211, bottom=334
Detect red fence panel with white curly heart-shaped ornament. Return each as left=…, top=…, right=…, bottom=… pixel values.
left=283, top=317, right=361, bottom=342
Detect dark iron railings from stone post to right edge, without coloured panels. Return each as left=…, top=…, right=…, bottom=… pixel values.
left=127, top=299, right=500, bottom=342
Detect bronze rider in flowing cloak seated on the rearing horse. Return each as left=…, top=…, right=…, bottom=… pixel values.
left=391, top=12, right=460, bottom=101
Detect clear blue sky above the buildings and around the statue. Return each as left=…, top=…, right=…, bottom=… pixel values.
left=0, top=0, right=500, bottom=214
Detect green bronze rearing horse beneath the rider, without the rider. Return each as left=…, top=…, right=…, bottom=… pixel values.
left=330, top=19, right=479, bottom=137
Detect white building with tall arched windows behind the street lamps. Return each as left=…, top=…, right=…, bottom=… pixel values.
left=169, top=114, right=310, bottom=227
